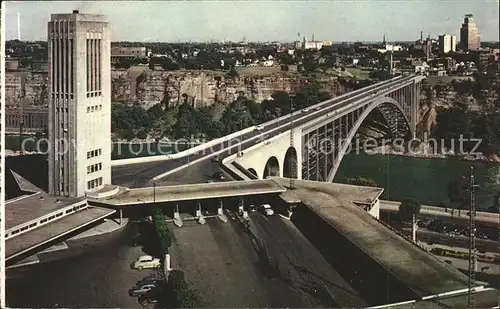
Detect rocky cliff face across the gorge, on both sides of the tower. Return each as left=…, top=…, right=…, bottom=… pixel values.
left=6, top=67, right=312, bottom=108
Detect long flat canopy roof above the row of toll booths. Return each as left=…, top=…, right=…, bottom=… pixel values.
left=99, top=179, right=286, bottom=206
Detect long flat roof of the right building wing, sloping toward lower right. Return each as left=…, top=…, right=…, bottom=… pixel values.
left=278, top=179, right=467, bottom=296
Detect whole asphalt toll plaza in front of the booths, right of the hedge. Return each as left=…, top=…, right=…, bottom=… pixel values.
left=166, top=211, right=366, bottom=308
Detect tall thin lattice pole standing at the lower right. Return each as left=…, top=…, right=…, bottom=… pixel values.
left=467, top=166, right=477, bottom=308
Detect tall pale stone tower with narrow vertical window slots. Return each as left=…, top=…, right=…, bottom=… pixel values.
left=48, top=11, right=111, bottom=197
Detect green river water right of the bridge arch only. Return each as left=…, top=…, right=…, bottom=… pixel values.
left=334, top=153, right=500, bottom=208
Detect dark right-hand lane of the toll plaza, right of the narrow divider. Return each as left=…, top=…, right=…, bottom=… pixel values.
left=249, top=212, right=367, bottom=308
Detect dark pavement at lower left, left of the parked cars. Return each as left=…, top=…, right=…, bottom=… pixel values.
left=6, top=225, right=153, bottom=308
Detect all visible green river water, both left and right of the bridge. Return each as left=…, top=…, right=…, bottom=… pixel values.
left=5, top=136, right=500, bottom=208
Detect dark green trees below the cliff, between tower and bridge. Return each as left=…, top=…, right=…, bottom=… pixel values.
left=111, top=81, right=330, bottom=140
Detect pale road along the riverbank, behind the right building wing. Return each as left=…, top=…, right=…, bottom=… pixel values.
left=380, top=200, right=500, bottom=227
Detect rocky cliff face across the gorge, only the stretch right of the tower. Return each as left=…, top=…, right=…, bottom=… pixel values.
left=118, top=69, right=300, bottom=107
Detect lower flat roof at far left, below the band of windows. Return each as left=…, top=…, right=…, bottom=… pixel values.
left=5, top=207, right=116, bottom=260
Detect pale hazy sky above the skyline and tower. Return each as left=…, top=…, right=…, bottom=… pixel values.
left=6, top=0, right=499, bottom=42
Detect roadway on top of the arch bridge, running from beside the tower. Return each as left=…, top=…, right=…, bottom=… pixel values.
left=111, top=76, right=414, bottom=188
